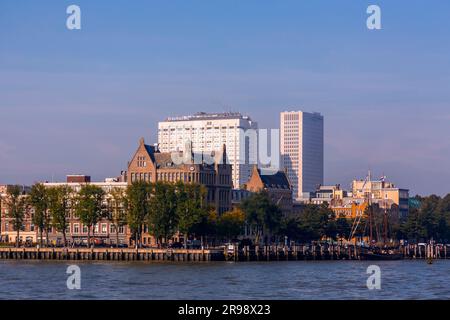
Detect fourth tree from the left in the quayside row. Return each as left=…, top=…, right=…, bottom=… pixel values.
left=75, top=184, right=105, bottom=246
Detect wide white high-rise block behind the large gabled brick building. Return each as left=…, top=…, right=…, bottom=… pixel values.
left=158, top=112, right=257, bottom=188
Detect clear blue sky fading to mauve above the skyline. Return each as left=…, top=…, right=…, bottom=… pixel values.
left=0, top=0, right=450, bottom=195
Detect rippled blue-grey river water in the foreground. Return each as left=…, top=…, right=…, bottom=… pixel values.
left=0, top=260, right=450, bottom=299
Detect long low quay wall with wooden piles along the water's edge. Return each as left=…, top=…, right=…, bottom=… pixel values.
left=0, top=245, right=450, bottom=262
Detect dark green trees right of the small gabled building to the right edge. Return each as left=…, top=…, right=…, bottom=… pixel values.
left=279, top=194, right=450, bottom=243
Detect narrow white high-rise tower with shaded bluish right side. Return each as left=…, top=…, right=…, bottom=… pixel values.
left=280, top=111, right=324, bottom=199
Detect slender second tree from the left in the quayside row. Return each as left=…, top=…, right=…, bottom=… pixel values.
left=28, top=183, right=51, bottom=247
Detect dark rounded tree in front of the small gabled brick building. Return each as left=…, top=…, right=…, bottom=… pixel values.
left=241, top=191, right=282, bottom=242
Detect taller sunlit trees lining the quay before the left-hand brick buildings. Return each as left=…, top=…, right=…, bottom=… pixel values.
left=0, top=182, right=268, bottom=246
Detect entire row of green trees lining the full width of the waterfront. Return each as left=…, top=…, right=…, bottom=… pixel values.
left=0, top=182, right=450, bottom=246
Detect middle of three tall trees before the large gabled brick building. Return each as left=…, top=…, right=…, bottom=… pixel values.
left=147, top=181, right=178, bottom=242
